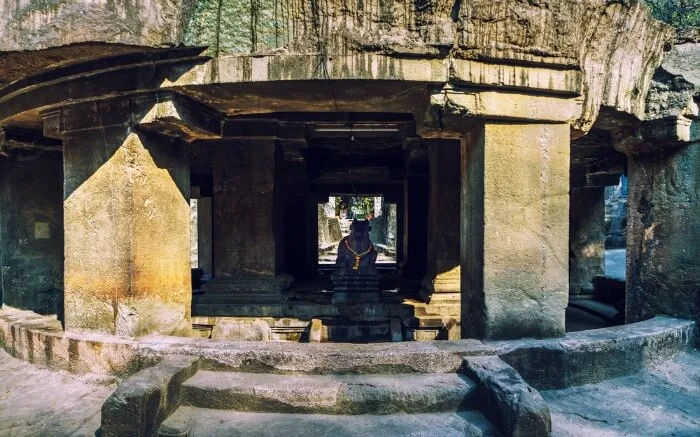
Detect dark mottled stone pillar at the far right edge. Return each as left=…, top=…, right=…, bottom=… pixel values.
left=626, top=143, right=700, bottom=323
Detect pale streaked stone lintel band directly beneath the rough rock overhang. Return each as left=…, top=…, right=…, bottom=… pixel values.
left=185, top=53, right=582, bottom=95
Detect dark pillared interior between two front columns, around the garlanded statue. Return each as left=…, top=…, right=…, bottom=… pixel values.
left=190, top=113, right=460, bottom=341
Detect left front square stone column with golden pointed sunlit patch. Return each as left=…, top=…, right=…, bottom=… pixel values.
left=64, top=124, right=192, bottom=336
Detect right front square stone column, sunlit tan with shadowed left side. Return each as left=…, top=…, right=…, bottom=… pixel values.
left=461, top=122, right=569, bottom=339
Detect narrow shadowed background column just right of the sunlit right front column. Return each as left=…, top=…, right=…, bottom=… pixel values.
left=569, top=187, right=605, bottom=295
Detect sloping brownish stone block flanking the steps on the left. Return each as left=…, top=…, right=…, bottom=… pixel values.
left=101, top=355, right=199, bottom=437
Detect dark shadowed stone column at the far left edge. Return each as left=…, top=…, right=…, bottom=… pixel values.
left=0, top=150, right=63, bottom=318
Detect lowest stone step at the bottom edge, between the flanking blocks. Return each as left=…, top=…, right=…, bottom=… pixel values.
left=158, top=406, right=499, bottom=437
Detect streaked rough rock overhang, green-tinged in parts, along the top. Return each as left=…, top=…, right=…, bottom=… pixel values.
left=0, top=0, right=673, bottom=131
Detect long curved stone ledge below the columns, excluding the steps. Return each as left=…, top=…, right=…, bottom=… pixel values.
left=0, top=309, right=695, bottom=389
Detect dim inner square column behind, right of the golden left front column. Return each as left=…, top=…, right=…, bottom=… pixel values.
left=204, top=138, right=288, bottom=295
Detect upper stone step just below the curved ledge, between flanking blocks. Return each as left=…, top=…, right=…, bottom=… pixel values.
left=182, top=370, right=476, bottom=415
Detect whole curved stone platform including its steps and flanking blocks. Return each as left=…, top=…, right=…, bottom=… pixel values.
left=0, top=309, right=696, bottom=436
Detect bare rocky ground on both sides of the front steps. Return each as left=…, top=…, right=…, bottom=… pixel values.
left=0, top=349, right=700, bottom=436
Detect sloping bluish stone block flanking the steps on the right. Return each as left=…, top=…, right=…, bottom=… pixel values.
left=464, top=356, right=552, bottom=436
